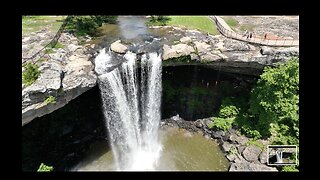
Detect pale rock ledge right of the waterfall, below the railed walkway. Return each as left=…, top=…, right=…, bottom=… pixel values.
left=162, top=28, right=299, bottom=75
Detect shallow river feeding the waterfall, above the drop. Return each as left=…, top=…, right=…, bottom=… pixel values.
left=92, top=16, right=188, bottom=48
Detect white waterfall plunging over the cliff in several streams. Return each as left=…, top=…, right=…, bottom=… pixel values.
left=95, top=49, right=162, bottom=170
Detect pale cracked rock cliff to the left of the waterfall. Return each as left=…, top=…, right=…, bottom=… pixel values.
left=22, top=31, right=97, bottom=125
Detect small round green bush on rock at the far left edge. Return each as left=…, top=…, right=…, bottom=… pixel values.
left=22, top=63, right=40, bottom=86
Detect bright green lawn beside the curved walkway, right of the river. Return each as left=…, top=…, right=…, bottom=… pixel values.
left=162, top=16, right=218, bottom=35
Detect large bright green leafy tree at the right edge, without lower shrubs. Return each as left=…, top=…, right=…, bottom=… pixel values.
left=249, top=58, right=299, bottom=144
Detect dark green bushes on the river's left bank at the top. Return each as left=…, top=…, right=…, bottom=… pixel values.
left=66, top=16, right=117, bottom=36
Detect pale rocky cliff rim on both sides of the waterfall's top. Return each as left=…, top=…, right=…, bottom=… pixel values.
left=22, top=23, right=299, bottom=125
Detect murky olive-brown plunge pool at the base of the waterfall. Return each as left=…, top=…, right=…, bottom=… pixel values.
left=72, top=127, right=229, bottom=171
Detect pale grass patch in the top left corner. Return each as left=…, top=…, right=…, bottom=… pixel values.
left=22, top=16, right=66, bottom=35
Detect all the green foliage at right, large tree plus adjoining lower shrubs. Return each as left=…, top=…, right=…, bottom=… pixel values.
left=210, top=59, right=299, bottom=145
